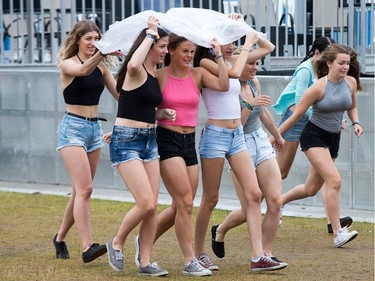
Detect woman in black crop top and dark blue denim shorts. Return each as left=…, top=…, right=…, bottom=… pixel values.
left=105, top=16, right=176, bottom=276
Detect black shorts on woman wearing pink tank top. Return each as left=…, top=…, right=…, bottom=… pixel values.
left=156, top=127, right=198, bottom=166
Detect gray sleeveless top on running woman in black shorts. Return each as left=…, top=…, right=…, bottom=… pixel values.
left=310, top=76, right=352, bottom=133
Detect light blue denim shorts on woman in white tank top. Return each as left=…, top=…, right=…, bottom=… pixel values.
left=199, top=124, right=246, bottom=158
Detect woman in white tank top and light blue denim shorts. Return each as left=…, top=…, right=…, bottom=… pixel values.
left=194, top=14, right=286, bottom=271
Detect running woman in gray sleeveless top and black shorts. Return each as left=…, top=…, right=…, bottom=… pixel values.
left=279, top=44, right=363, bottom=248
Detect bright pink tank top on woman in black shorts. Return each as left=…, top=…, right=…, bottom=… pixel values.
left=158, top=67, right=200, bottom=127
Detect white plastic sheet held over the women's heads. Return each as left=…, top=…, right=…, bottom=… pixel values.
left=95, top=8, right=265, bottom=54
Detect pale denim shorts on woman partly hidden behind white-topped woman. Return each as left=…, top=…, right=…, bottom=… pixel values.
left=245, top=128, right=276, bottom=168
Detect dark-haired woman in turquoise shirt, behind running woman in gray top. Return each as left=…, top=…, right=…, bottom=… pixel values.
left=273, top=37, right=353, bottom=233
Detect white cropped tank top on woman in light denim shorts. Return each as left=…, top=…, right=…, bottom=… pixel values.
left=202, top=78, right=241, bottom=120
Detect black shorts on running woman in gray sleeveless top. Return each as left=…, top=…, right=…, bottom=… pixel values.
left=300, top=121, right=341, bottom=158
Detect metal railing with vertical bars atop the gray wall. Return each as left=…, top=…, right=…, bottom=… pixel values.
left=0, top=0, right=375, bottom=74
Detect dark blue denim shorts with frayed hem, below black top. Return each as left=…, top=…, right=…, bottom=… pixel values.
left=109, top=126, right=159, bottom=167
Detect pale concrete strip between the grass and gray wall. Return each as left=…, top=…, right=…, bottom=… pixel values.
left=0, top=179, right=374, bottom=223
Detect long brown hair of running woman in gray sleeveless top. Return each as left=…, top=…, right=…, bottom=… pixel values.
left=315, top=44, right=362, bottom=90
